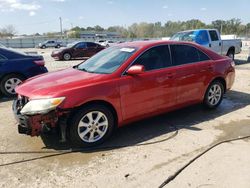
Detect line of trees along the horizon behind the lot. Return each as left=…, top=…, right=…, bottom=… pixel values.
left=69, top=18, right=250, bottom=38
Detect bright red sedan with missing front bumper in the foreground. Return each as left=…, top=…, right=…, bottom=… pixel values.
left=13, top=41, right=235, bottom=146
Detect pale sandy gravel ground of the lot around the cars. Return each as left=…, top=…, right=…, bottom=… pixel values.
left=0, top=49, right=250, bottom=188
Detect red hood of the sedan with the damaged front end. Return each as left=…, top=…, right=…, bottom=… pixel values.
left=16, top=68, right=107, bottom=99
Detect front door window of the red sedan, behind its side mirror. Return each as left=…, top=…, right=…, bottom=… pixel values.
left=134, top=45, right=171, bottom=71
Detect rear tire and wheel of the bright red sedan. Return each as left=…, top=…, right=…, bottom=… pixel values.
left=203, top=81, right=225, bottom=109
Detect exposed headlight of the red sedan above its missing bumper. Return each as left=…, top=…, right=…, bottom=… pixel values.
left=21, top=97, right=65, bottom=115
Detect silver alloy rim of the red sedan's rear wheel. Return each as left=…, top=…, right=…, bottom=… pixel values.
left=208, top=84, right=222, bottom=106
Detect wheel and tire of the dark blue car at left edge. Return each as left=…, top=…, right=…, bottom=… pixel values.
left=0, top=74, right=25, bottom=97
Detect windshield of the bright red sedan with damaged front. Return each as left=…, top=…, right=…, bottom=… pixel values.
left=77, top=46, right=137, bottom=74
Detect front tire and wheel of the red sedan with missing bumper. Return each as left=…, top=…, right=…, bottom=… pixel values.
left=69, top=105, right=115, bottom=147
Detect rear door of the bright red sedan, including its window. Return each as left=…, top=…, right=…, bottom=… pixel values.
left=171, top=44, right=204, bottom=105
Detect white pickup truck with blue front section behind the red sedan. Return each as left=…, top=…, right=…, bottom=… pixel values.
left=170, top=29, right=242, bottom=59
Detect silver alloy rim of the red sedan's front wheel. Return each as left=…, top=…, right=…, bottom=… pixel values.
left=78, top=111, right=108, bottom=143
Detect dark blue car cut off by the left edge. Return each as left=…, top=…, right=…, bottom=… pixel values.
left=0, top=47, right=48, bottom=97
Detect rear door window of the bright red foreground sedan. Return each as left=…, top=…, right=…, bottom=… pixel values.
left=171, top=44, right=200, bottom=65
